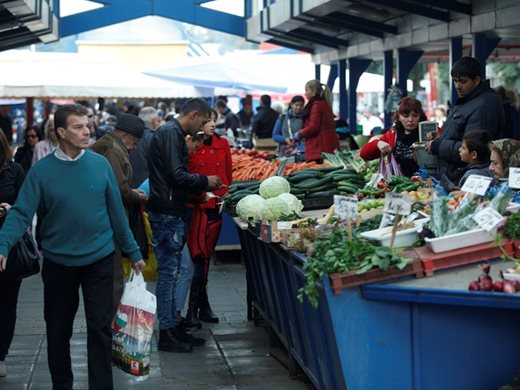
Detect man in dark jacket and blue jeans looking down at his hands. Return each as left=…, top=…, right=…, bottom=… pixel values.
left=147, top=99, right=223, bottom=352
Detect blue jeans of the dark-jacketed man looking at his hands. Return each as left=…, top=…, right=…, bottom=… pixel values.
left=148, top=212, right=189, bottom=330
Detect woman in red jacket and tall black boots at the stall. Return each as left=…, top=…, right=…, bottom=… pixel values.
left=186, top=109, right=233, bottom=328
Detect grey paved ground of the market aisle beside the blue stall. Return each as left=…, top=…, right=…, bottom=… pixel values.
left=0, top=263, right=313, bottom=390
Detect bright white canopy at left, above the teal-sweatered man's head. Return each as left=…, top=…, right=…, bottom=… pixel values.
left=0, top=51, right=215, bottom=99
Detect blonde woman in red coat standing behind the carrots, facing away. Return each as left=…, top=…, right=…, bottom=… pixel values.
left=294, top=80, right=340, bottom=162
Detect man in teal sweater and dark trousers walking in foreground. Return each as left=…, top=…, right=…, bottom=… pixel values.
left=0, top=104, right=145, bottom=389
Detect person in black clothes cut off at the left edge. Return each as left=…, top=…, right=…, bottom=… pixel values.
left=0, top=131, right=25, bottom=377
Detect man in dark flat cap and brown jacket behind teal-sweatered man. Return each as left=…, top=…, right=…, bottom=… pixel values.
left=90, top=113, right=147, bottom=314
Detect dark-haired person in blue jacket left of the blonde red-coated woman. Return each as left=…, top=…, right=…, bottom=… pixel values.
left=273, top=95, right=305, bottom=156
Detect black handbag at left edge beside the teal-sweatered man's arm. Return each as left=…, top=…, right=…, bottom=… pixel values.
left=0, top=231, right=40, bottom=280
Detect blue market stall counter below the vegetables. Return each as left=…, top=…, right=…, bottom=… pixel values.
left=237, top=221, right=520, bottom=390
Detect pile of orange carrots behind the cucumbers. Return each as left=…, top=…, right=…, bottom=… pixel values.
left=231, top=154, right=325, bottom=181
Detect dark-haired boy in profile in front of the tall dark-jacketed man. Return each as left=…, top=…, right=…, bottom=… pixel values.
left=458, top=130, right=493, bottom=188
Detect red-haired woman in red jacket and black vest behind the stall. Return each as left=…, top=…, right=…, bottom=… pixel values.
left=360, top=97, right=426, bottom=177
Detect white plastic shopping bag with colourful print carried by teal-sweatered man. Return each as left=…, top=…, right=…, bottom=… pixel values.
left=112, top=270, right=157, bottom=380
